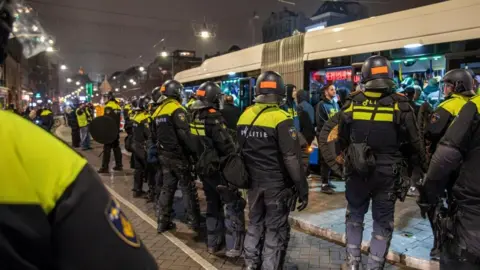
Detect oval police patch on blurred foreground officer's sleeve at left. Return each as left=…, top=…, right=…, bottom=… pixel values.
left=105, top=198, right=140, bottom=248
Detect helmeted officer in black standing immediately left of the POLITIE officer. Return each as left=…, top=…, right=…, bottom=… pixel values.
left=190, top=82, right=246, bottom=257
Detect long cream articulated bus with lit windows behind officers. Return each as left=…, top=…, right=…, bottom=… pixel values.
left=175, top=0, right=480, bottom=167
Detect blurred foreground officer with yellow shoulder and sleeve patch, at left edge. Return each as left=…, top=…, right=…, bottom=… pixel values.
left=0, top=0, right=158, bottom=270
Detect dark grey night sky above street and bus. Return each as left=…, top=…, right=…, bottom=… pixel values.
left=27, top=0, right=439, bottom=79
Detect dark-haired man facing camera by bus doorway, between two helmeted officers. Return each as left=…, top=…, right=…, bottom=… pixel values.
left=315, top=84, right=340, bottom=194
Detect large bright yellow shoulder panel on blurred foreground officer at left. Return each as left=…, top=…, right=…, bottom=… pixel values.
left=0, top=111, right=87, bottom=215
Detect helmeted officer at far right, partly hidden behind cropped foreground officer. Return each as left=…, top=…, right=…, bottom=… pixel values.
left=425, top=69, right=475, bottom=154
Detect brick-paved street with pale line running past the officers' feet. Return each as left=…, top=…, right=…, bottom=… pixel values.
left=57, top=127, right=402, bottom=270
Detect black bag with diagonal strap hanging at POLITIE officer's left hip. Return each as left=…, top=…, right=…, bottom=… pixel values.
left=220, top=107, right=270, bottom=189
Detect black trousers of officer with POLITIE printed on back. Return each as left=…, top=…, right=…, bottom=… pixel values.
left=244, top=187, right=293, bottom=270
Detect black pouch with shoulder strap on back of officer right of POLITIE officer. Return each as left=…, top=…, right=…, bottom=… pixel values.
left=347, top=102, right=378, bottom=179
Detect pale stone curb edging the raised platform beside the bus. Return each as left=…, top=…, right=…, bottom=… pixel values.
left=289, top=216, right=440, bottom=270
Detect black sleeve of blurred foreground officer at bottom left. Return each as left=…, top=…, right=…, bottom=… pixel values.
left=49, top=165, right=158, bottom=270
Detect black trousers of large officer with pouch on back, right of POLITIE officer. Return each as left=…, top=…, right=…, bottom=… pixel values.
left=345, top=166, right=397, bottom=269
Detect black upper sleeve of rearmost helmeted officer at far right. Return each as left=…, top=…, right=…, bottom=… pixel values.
left=425, top=108, right=453, bottom=149
